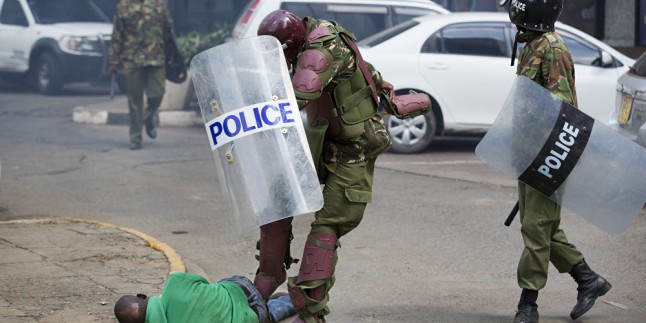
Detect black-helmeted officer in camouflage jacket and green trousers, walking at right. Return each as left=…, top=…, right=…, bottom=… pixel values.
left=501, top=0, right=612, bottom=323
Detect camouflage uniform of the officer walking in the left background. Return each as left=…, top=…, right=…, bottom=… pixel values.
left=109, top=0, right=172, bottom=144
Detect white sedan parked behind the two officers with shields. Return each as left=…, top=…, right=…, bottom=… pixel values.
left=359, top=12, right=634, bottom=153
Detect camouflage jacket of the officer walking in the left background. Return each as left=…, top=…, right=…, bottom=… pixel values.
left=108, top=0, right=173, bottom=68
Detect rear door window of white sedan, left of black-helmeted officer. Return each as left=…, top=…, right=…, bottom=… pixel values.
left=422, top=24, right=507, bottom=57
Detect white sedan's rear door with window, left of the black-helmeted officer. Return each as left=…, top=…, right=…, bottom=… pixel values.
left=419, top=22, right=515, bottom=128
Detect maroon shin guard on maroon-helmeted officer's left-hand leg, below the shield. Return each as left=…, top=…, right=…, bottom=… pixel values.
left=253, top=218, right=298, bottom=300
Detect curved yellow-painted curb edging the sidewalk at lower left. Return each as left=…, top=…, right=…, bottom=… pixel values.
left=0, top=217, right=186, bottom=275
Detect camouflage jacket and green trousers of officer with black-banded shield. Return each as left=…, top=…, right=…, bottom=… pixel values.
left=517, top=31, right=583, bottom=290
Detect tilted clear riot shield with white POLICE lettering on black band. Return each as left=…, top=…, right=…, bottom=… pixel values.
left=476, top=76, right=646, bottom=234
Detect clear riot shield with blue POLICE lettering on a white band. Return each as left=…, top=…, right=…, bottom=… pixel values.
left=190, top=36, right=323, bottom=231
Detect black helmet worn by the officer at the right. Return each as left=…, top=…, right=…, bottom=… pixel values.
left=500, top=0, right=563, bottom=32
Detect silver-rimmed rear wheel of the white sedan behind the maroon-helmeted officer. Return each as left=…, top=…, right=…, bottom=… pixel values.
left=386, top=112, right=437, bottom=154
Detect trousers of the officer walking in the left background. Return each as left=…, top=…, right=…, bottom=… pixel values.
left=123, top=66, right=166, bottom=143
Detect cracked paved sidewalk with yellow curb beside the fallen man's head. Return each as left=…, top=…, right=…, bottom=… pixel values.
left=0, top=219, right=186, bottom=323
